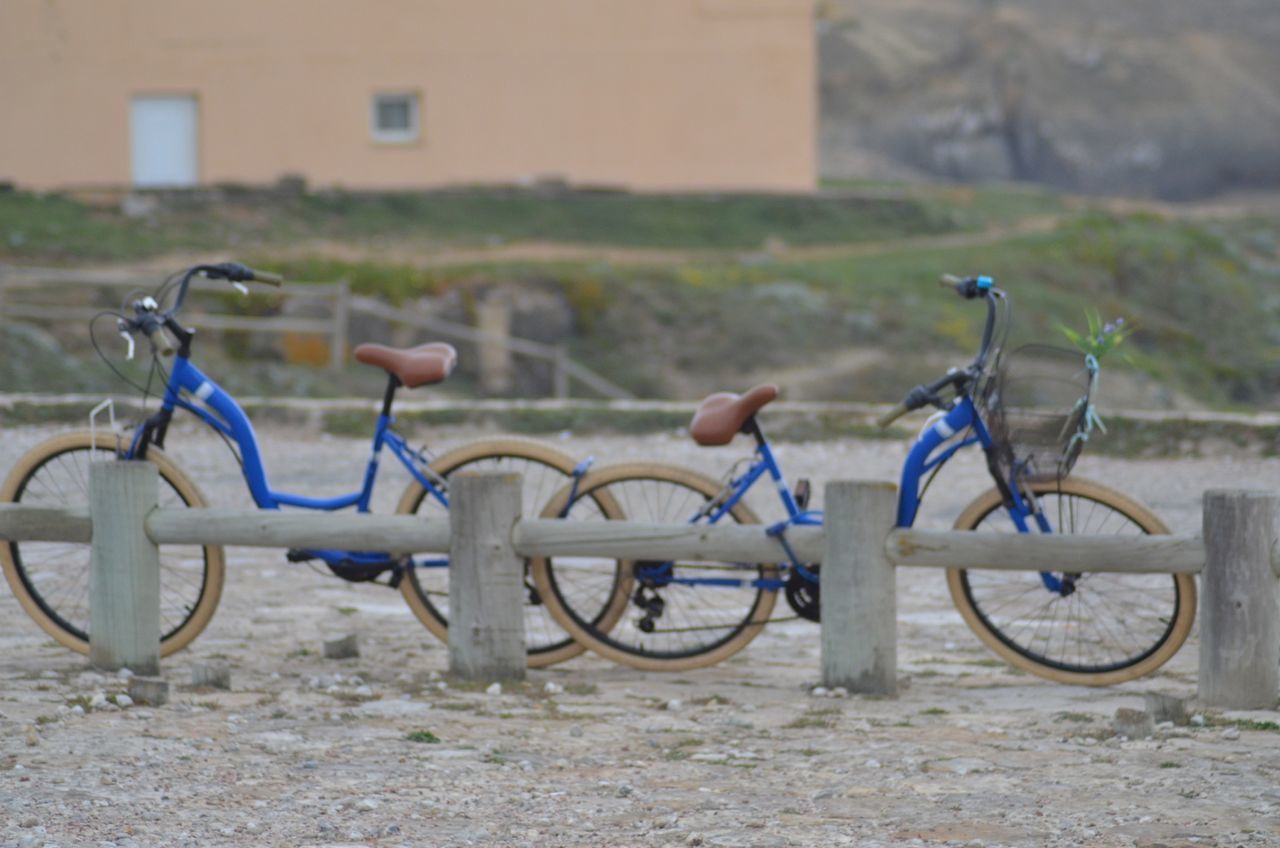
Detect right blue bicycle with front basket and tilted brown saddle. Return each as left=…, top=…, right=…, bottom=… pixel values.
left=532, top=277, right=1196, bottom=685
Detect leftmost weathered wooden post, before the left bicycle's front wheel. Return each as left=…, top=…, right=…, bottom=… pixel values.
left=88, top=459, right=160, bottom=675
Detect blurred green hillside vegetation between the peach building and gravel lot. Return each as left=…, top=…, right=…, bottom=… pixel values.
left=0, top=184, right=1280, bottom=409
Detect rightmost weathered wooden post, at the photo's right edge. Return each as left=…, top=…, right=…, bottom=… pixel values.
left=1199, top=491, right=1280, bottom=710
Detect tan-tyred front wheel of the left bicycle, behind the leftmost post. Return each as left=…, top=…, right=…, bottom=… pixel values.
left=0, top=430, right=225, bottom=656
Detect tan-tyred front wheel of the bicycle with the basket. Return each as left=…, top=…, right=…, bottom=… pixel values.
left=947, top=478, right=1196, bottom=685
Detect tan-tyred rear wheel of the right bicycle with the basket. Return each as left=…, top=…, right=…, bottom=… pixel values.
left=530, top=462, right=780, bottom=671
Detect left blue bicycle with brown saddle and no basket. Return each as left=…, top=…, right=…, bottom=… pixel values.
left=0, top=263, right=617, bottom=666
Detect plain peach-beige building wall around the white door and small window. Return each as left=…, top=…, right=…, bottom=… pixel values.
left=0, top=0, right=817, bottom=191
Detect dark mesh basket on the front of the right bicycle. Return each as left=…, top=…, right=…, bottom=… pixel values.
left=983, top=345, right=1097, bottom=482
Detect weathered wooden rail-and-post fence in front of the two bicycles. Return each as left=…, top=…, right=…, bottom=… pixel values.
left=0, top=473, right=1280, bottom=708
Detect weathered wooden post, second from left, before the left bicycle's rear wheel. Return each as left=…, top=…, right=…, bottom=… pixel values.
left=449, top=473, right=526, bottom=680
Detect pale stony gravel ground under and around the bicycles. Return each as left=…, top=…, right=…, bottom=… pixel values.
left=0, top=430, right=1280, bottom=848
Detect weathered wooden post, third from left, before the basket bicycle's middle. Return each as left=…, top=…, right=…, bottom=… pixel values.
left=820, top=480, right=897, bottom=696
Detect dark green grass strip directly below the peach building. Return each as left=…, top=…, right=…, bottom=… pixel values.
left=0, top=188, right=957, bottom=261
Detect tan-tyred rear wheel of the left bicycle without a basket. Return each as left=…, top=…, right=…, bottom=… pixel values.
left=397, top=439, right=614, bottom=667
